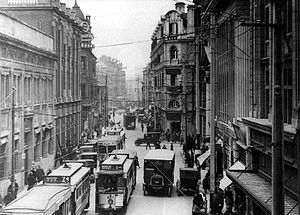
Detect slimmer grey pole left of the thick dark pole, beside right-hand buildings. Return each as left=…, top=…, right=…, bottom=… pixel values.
left=210, top=14, right=217, bottom=208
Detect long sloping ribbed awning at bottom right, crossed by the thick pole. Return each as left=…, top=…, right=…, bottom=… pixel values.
left=226, top=170, right=299, bottom=215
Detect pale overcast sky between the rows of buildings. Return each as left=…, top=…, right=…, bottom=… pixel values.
left=61, top=0, right=186, bottom=76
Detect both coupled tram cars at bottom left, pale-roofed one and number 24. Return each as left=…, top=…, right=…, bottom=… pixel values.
left=0, top=163, right=90, bottom=215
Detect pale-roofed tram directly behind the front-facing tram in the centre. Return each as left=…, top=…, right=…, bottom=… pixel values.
left=97, top=134, right=125, bottom=163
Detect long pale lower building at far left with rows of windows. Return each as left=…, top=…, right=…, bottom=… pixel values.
left=0, top=11, right=58, bottom=194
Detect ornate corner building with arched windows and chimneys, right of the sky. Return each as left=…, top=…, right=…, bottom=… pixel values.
left=151, top=2, right=195, bottom=137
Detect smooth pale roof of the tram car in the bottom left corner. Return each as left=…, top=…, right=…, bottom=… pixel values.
left=0, top=185, right=71, bottom=214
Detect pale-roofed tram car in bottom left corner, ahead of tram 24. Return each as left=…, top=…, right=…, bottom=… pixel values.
left=0, top=184, right=72, bottom=215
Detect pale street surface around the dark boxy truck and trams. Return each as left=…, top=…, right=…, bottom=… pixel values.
left=87, top=112, right=193, bottom=215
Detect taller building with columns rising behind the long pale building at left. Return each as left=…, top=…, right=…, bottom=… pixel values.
left=0, top=0, right=84, bottom=166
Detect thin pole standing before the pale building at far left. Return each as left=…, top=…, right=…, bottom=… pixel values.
left=11, top=87, right=16, bottom=196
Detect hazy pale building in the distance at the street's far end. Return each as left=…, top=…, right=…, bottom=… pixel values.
left=97, top=55, right=126, bottom=108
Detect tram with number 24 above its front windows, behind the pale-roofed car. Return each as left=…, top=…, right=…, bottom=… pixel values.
left=44, top=163, right=91, bottom=215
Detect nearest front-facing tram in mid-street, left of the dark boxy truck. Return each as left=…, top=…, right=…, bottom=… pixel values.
left=95, top=154, right=136, bottom=214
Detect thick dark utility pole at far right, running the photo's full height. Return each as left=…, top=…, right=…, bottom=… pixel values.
left=271, top=0, right=284, bottom=215
